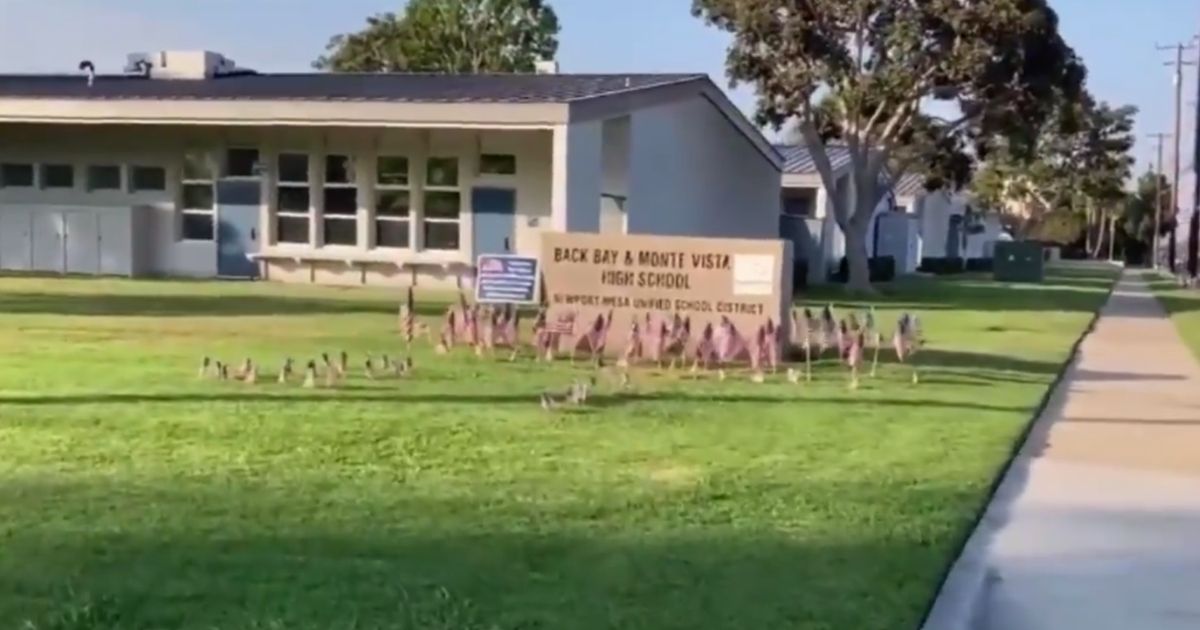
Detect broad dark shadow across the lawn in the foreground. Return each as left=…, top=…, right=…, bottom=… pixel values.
left=0, top=479, right=983, bottom=630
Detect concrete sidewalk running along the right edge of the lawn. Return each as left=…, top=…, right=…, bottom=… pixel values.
left=924, top=272, right=1200, bottom=630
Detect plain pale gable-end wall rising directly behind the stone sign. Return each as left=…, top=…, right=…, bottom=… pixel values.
left=626, top=96, right=780, bottom=239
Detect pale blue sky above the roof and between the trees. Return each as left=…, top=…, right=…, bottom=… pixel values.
left=0, top=0, right=1200, bottom=171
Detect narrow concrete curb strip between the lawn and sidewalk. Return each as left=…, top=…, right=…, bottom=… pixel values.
left=920, top=269, right=1127, bottom=630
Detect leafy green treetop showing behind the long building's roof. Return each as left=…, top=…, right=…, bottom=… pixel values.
left=313, top=0, right=558, bottom=73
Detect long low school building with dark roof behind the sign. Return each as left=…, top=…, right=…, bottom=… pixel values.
left=0, top=52, right=782, bottom=287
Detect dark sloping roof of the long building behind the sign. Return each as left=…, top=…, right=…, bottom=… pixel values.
left=0, top=72, right=708, bottom=103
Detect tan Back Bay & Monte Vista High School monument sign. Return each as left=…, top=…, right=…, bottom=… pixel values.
left=541, top=232, right=792, bottom=354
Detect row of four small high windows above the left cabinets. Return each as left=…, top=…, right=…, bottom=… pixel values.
left=0, top=162, right=167, bottom=192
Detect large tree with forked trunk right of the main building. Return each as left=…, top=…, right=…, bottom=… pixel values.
left=692, top=0, right=1085, bottom=290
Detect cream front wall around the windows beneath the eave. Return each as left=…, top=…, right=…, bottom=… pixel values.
left=0, top=125, right=551, bottom=276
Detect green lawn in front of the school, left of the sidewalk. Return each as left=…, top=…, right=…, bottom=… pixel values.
left=0, top=267, right=1112, bottom=630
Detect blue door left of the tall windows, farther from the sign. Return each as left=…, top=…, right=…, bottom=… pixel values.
left=217, top=181, right=259, bottom=278
